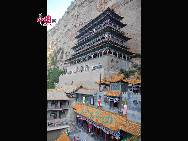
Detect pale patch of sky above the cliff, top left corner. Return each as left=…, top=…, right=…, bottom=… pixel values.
left=47, top=0, right=74, bottom=30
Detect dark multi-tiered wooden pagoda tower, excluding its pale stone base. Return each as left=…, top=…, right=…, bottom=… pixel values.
left=66, top=8, right=132, bottom=67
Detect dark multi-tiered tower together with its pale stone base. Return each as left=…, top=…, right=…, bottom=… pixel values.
left=59, top=8, right=133, bottom=88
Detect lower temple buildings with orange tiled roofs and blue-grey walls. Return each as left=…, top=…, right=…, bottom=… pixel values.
left=72, top=74, right=141, bottom=141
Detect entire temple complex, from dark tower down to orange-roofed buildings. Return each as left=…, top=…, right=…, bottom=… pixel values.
left=47, top=8, right=141, bottom=141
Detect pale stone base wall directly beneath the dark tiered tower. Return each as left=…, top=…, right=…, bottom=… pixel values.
left=58, top=55, right=129, bottom=89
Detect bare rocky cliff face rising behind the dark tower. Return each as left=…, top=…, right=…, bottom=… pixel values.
left=47, top=0, right=141, bottom=66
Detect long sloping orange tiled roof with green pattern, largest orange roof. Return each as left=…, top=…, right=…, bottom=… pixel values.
left=73, top=103, right=141, bottom=136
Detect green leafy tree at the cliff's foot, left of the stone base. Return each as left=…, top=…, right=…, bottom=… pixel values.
left=47, top=67, right=64, bottom=89
